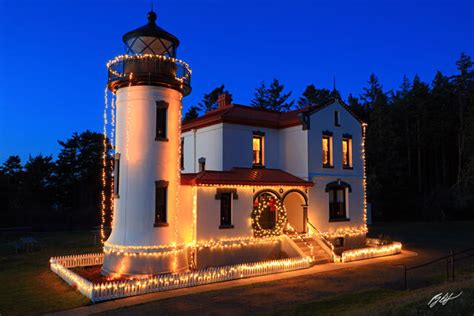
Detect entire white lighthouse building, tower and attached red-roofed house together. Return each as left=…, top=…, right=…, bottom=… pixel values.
left=103, top=12, right=367, bottom=275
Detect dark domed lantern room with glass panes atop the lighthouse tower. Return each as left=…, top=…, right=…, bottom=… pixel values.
left=123, top=11, right=179, bottom=57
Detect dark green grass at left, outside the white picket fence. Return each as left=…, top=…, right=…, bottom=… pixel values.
left=0, top=231, right=100, bottom=316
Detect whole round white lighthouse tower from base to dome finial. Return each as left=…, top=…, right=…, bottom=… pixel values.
left=102, top=11, right=191, bottom=275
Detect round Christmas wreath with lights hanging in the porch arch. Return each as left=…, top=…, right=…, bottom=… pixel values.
left=251, top=194, right=287, bottom=237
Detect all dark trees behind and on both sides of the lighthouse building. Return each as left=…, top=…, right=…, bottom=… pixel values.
left=0, top=54, right=474, bottom=229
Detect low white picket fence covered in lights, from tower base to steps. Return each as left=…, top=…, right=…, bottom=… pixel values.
left=50, top=253, right=311, bottom=302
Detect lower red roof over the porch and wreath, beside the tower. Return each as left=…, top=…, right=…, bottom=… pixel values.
left=181, top=168, right=313, bottom=187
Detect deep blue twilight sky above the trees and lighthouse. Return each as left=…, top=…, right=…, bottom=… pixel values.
left=0, top=0, right=474, bottom=163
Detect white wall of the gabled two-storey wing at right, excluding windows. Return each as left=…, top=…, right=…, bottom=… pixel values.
left=308, top=103, right=364, bottom=232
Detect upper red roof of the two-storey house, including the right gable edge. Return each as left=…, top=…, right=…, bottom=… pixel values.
left=182, top=98, right=364, bottom=132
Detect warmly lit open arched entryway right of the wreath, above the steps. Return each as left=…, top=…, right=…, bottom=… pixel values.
left=283, top=190, right=308, bottom=233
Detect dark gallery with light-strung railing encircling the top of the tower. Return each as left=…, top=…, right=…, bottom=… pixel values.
left=107, top=54, right=191, bottom=95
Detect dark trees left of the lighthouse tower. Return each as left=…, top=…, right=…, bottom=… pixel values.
left=0, top=131, right=113, bottom=230
